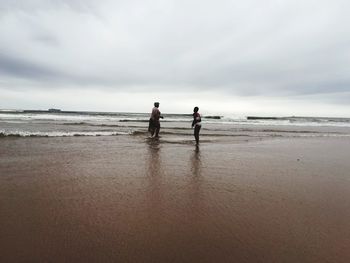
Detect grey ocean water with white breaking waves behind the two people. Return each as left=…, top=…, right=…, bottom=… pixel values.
left=0, top=110, right=350, bottom=137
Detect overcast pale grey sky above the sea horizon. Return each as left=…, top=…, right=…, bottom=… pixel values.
left=0, top=0, right=350, bottom=117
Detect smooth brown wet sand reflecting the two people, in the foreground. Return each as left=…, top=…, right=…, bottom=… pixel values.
left=0, top=136, right=350, bottom=263
